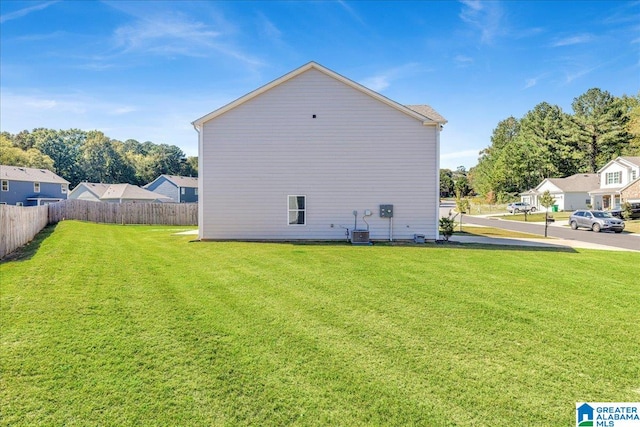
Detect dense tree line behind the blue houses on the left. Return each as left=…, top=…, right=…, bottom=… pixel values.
left=0, top=128, right=198, bottom=188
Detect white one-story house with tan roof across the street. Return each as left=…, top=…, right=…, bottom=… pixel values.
left=520, top=173, right=599, bottom=211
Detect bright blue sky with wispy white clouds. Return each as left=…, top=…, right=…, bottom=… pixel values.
left=0, top=0, right=640, bottom=169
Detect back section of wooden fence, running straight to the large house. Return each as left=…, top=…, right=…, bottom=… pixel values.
left=49, top=200, right=198, bottom=225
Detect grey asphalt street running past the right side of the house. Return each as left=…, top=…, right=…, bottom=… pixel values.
left=440, top=203, right=640, bottom=251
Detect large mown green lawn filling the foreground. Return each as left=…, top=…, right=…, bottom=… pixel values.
left=0, top=221, right=640, bottom=426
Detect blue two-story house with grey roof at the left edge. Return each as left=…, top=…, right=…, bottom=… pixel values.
left=0, top=165, right=69, bottom=206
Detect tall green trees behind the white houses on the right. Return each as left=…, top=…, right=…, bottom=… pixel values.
left=468, top=88, right=640, bottom=200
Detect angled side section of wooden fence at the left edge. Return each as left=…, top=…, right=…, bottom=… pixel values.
left=0, top=205, right=49, bottom=258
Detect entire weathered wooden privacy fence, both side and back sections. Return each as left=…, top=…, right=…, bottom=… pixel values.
left=0, top=200, right=198, bottom=258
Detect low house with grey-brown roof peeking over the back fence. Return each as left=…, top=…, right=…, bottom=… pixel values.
left=69, top=182, right=172, bottom=203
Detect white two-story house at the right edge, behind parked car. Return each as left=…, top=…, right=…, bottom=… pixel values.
left=589, top=157, right=640, bottom=209
